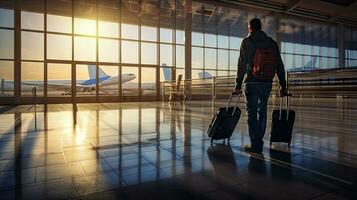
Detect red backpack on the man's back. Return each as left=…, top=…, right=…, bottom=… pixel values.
left=251, top=38, right=276, bottom=80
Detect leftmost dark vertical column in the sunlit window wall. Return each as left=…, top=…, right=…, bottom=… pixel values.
left=14, top=0, right=21, bottom=104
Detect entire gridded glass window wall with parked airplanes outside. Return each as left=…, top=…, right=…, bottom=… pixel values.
left=0, top=0, right=357, bottom=101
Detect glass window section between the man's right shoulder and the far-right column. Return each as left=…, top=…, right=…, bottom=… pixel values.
left=277, top=19, right=338, bottom=71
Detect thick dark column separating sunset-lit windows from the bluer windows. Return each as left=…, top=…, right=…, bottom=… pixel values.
left=185, top=0, right=192, bottom=99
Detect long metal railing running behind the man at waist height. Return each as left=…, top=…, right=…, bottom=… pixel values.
left=161, top=69, right=357, bottom=100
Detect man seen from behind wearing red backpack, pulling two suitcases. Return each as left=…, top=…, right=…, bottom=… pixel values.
left=232, top=18, right=287, bottom=153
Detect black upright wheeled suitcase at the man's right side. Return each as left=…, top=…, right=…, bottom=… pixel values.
left=270, top=94, right=295, bottom=148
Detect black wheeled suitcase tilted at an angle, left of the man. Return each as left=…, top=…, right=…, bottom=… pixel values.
left=207, top=95, right=242, bottom=144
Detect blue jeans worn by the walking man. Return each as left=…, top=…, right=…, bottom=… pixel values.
left=244, top=82, right=272, bottom=149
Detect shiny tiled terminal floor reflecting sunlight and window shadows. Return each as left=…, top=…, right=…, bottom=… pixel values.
left=0, top=99, right=357, bottom=200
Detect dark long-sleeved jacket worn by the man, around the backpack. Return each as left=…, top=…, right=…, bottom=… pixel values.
left=236, top=31, right=286, bottom=89
